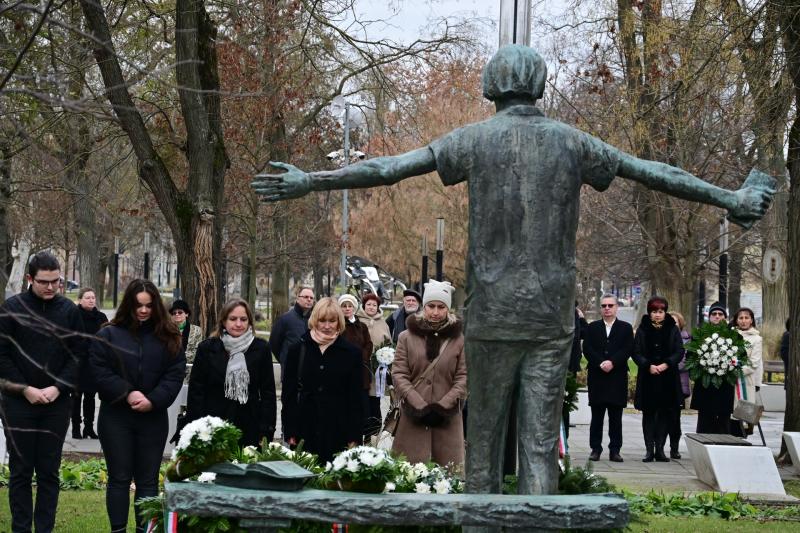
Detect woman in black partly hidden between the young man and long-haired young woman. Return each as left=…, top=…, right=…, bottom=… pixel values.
left=72, top=287, right=108, bottom=439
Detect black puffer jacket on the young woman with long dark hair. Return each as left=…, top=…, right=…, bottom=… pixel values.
left=89, top=322, right=186, bottom=411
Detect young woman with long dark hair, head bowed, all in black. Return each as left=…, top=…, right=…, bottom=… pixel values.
left=89, top=279, right=186, bottom=532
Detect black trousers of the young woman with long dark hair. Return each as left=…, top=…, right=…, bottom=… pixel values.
left=97, top=402, right=169, bottom=533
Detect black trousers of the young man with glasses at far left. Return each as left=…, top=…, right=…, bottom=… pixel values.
left=3, top=393, right=70, bottom=533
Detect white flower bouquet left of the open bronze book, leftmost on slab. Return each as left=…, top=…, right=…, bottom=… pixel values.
left=167, top=416, right=242, bottom=481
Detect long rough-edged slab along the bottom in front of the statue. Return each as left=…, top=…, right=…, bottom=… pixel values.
left=164, top=482, right=629, bottom=531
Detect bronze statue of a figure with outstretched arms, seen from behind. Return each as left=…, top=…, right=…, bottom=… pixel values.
left=252, top=45, right=775, bottom=494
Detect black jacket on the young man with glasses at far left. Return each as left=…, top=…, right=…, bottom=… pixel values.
left=0, top=289, right=86, bottom=393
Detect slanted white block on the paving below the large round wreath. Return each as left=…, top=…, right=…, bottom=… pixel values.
left=685, top=439, right=786, bottom=495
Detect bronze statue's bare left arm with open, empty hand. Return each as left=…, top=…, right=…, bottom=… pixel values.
left=250, top=147, right=436, bottom=202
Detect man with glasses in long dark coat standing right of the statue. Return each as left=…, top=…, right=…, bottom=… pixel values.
left=583, top=294, right=633, bottom=463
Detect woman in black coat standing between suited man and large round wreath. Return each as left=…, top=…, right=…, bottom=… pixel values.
left=633, top=296, right=683, bottom=463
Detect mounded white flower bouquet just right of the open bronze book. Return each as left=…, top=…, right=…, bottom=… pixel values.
left=324, top=446, right=399, bottom=493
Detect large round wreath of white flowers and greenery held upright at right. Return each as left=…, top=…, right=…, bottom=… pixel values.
left=686, top=322, right=750, bottom=388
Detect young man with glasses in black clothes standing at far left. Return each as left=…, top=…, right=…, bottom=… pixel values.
left=0, top=252, right=85, bottom=533
